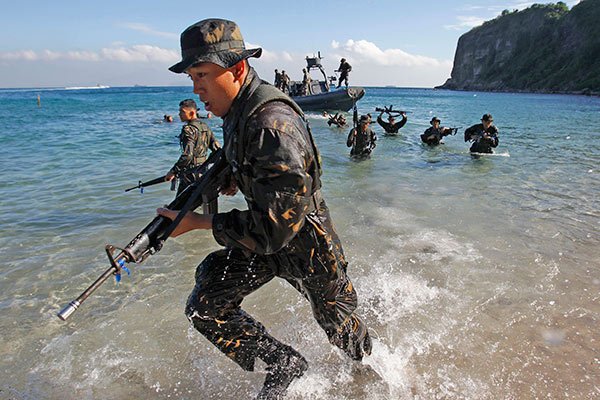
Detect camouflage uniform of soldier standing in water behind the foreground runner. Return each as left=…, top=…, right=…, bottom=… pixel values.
left=170, top=119, right=221, bottom=194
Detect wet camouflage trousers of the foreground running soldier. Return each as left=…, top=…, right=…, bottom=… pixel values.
left=186, top=214, right=371, bottom=371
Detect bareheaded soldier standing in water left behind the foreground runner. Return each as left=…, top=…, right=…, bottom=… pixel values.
left=165, top=99, right=221, bottom=194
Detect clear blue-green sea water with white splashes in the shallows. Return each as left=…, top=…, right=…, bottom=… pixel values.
left=0, top=87, right=600, bottom=400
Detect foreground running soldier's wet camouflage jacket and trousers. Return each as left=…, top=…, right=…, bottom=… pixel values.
left=186, top=69, right=370, bottom=371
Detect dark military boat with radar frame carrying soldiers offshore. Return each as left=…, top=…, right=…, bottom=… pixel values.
left=289, top=52, right=365, bottom=111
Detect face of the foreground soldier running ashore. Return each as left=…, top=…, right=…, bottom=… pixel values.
left=185, top=62, right=246, bottom=117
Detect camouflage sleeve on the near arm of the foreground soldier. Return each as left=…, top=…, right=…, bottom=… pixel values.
left=213, top=124, right=314, bottom=254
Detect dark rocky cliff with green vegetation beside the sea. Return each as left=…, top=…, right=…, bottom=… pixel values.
left=439, top=0, right=600, bottom=94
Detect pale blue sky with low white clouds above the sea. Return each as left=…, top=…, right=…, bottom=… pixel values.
left=0, top=0, right=578, bottom=87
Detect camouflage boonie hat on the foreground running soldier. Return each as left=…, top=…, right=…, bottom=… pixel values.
left=169, top=18, right=262, bottom=74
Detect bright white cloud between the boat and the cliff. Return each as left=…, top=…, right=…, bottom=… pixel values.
left=331, top=39, right=452, bottom=67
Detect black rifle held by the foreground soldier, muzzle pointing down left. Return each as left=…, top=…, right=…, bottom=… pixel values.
left=57, top=149, right=228, bottom=321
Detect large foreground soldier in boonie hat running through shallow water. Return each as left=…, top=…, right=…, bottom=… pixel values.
left=157, top=19, right=371, bottom=399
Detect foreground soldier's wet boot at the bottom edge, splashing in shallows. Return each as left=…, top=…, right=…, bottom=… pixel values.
left=256, top=336, right=308, bottom=400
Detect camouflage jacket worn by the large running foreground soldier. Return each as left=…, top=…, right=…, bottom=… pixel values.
left=213, top=69, right=326, bottom=254
